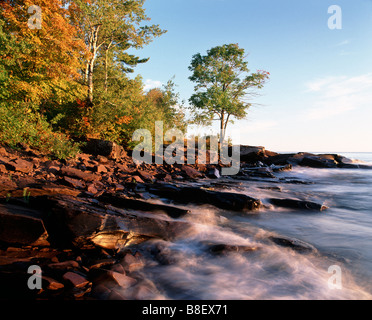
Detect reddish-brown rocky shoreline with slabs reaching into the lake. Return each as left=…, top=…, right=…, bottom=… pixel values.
left=0, top=140, right=371, bottom=300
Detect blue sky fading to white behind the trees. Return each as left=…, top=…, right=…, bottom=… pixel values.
left=130, top=0, right=372, bottom=152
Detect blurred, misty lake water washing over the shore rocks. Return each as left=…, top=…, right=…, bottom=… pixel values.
left=140, top=153, right=372, bottom=300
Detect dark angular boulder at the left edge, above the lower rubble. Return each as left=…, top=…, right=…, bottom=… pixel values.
left=0, top=204, right=49, bottom=246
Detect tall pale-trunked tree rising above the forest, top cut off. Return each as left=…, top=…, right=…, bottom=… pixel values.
left=74, top=0, right=165, bottom=104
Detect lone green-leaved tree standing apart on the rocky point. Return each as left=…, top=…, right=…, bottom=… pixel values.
left=189, top=44, right=270, bottom=143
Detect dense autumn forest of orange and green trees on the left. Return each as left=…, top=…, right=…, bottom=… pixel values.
left=0, top=0, right=186, bottom=159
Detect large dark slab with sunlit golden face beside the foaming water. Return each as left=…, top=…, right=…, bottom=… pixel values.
left=44, top=197, right=190, bottom=250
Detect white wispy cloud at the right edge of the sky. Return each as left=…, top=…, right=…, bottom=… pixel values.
left=303, top=73, right=372, bottom=120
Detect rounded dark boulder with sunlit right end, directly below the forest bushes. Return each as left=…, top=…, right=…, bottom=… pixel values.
left=82, top=139, right=126, bottom=160
